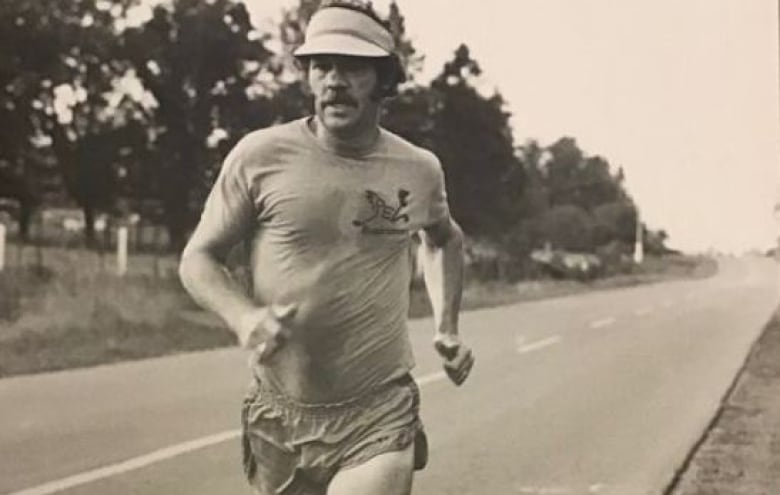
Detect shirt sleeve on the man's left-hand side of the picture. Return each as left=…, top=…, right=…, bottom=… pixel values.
left=198, top=143, right=256, bottom=245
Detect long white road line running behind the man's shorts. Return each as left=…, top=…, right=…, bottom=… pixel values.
left=5, top=371, right=447, bottom=495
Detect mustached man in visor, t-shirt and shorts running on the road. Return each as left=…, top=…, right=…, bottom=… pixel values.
left=180, top=1, right=474, bottom=495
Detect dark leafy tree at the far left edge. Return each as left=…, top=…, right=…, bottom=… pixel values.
left=0, top=0, right=140, bottom=240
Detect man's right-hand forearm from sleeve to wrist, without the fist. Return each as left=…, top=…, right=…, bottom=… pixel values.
left=421, top=223, right=463, bottom=334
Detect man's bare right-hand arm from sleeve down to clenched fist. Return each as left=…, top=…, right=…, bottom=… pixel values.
left=420, top=217, right=474, bottom=385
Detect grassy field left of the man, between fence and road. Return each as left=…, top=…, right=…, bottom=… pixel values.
left=0, top=247, right=233, bottom=376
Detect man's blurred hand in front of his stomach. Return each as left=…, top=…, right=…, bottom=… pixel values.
left=239, top=304, right=297, bottom=364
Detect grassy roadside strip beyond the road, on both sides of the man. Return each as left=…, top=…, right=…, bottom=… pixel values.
left=0, top=247, right=717, bottom=377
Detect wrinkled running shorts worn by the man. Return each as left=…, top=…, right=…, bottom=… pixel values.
left=241, top=375, right=428, bottom=495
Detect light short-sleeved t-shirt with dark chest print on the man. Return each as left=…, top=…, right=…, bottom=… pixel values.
left=201, top=119, right=449, bottom=402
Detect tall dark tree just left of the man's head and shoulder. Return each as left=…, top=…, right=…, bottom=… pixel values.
left=124, top=0, right=273, bottom=246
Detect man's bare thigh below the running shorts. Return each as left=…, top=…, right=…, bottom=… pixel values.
left=328, top=444, right=414, bottom=495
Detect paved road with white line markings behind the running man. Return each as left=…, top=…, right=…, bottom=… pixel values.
left=0, top=259, right=779, bottom=495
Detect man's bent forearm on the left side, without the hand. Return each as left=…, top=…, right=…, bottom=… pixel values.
left=179, top=252, right=259, bottom=337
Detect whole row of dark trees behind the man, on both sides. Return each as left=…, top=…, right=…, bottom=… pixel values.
left=0, top=0, right=666, bottom=273
